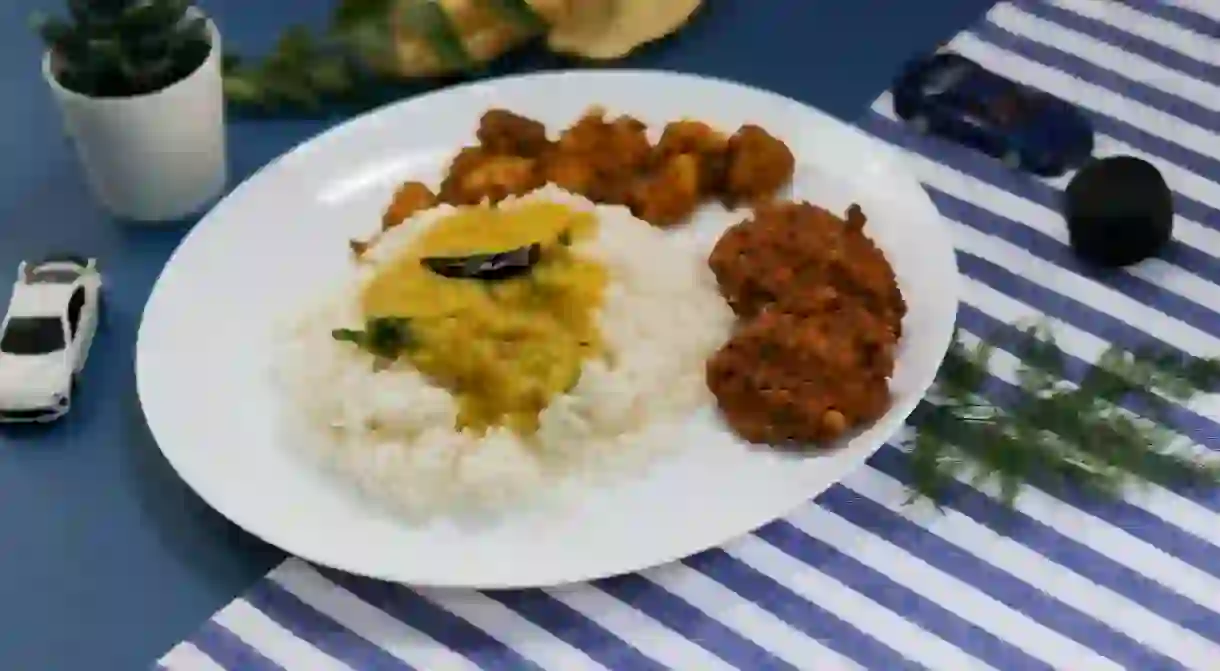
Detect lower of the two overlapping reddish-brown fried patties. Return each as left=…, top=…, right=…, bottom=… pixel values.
left=706, top=309, right=894, bottom=445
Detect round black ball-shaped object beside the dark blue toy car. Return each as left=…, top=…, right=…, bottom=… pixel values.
left=1064, top=156, right=1174, bottom=268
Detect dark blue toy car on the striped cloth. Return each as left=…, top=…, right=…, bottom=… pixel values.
left=893, top=51, right=1093, bottom=177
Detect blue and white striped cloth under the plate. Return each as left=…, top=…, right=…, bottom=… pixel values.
left=160, top=0, right=1220, bottom=671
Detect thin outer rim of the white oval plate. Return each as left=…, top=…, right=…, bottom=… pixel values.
left=133, top=68, right=961, bottom=590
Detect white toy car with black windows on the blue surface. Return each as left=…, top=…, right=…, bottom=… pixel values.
left=0, top=256, right=101, bottom=422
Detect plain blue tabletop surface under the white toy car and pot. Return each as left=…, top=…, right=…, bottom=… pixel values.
left=0, top=0, right=991, bottom=671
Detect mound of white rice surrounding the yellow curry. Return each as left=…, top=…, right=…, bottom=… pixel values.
left=276, top=187, right=733, bottom=519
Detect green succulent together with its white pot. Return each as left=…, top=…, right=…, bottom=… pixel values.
left=35, top=0, right=228, bottom=221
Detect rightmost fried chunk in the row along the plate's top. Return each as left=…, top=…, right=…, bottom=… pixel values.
left=721, top=124, right=797, bottom=207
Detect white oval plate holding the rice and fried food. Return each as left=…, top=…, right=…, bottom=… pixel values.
left=137, top=71, right=958, bottom=588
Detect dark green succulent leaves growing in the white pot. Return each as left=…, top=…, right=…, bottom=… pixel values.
left=33, top=0, right=212, bottom=98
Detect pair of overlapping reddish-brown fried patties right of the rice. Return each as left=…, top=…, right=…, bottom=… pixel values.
left=708, top=203, right=906, bottom=444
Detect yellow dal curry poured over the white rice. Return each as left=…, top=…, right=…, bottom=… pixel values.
left=361, top=203, right=609, bottom=436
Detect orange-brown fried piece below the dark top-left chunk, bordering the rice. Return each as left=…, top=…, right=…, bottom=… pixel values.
left=440, top=148, right=543, bottom=205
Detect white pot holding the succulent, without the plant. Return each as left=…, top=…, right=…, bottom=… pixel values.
left=43, top=14, right=228, bottom=222
